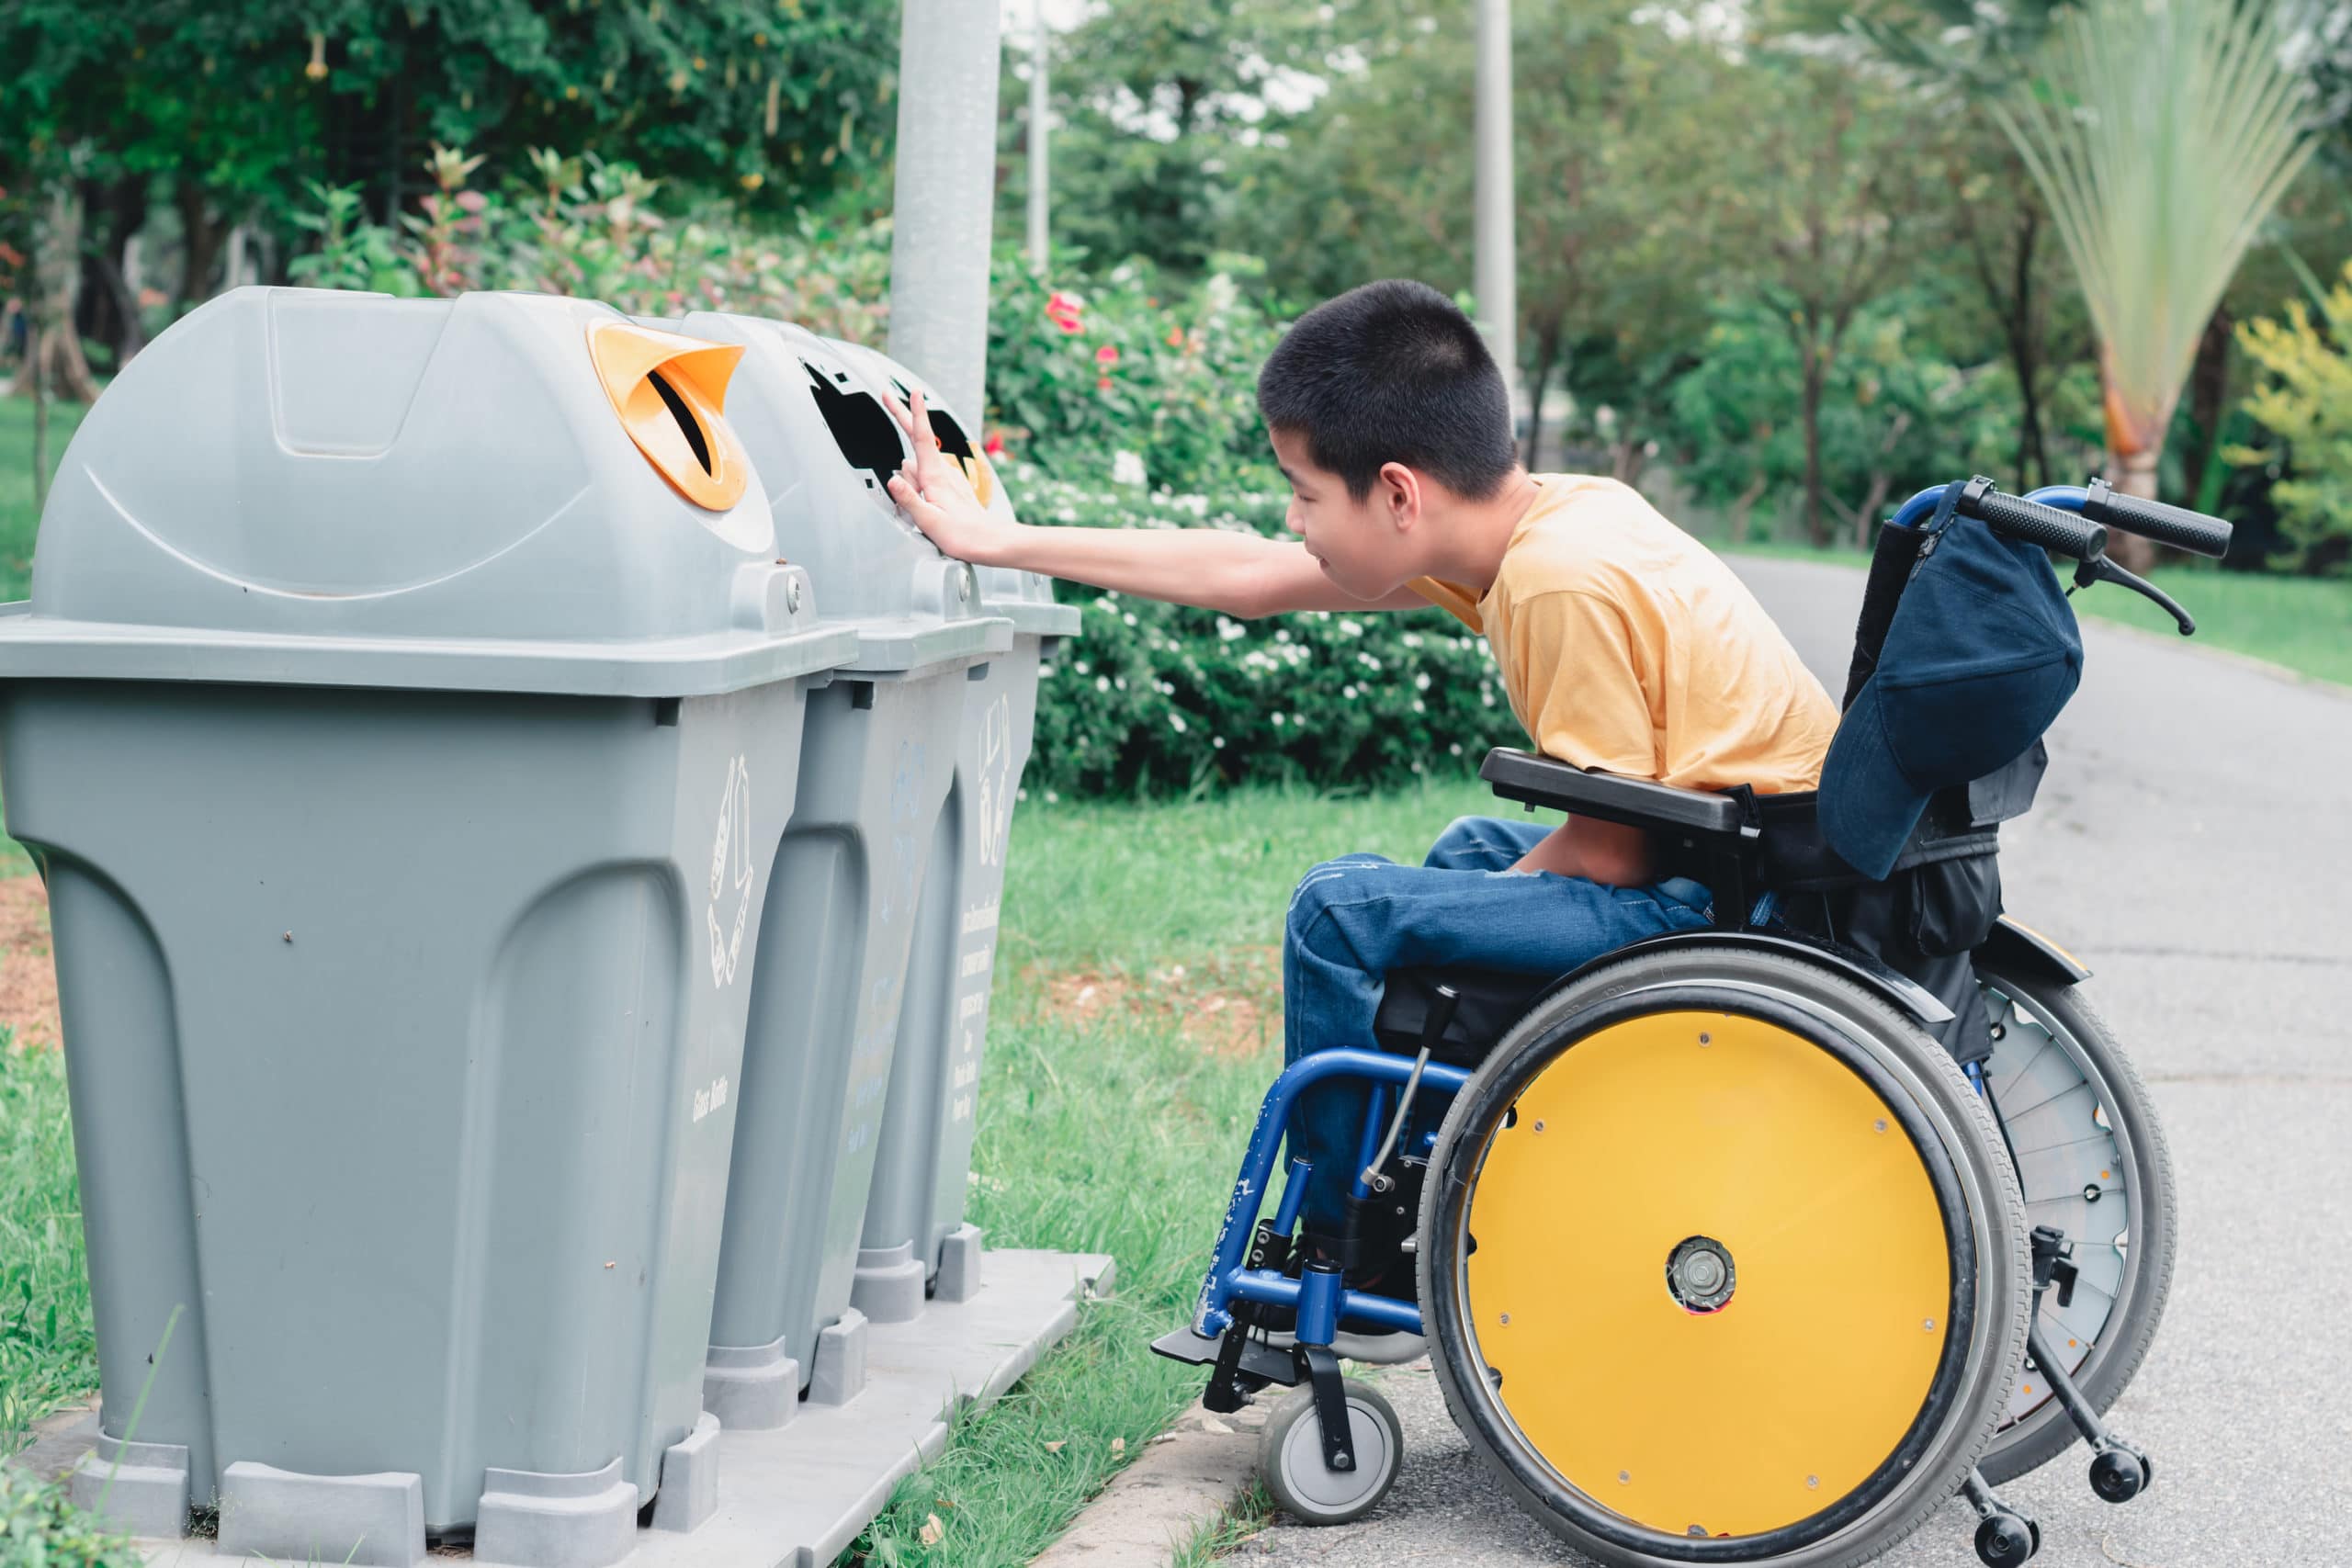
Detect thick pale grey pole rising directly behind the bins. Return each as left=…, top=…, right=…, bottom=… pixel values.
left=889, top=0, right=1000, bottom=415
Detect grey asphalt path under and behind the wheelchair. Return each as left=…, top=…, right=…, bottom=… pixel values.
left=1238, top=559, right=2352, bottom=1568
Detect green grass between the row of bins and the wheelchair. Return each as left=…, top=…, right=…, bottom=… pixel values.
left=844, top=778, right=1496, bottom=1565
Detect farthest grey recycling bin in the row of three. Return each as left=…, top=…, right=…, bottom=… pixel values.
left=818, top=344, right=1080, bottom=1324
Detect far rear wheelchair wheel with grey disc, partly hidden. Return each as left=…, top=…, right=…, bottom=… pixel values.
left=1975, top=959, right=2178, bottom=1485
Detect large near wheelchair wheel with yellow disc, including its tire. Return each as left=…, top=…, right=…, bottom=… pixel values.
left=1416, top=942, right=2030, bottom=1568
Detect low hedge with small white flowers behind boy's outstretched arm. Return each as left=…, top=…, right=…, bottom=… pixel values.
left=1007, top=468, right=1524, bottom=797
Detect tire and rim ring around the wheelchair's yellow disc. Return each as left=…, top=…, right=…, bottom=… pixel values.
left=1419, top=945, right=2032, bottom=1568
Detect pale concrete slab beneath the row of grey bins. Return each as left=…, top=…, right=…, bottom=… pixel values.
left=71, top=1251, right=1113, bottom=1568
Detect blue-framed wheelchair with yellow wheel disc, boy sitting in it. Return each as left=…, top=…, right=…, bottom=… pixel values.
left=1152, top=479, right=2230, bottom=1568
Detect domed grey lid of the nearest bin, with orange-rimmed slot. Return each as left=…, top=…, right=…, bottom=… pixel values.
left=0, top=289, right=856, bottom=696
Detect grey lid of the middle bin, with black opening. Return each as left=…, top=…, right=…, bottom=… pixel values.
left=677, top=310, right=1013, bottom=672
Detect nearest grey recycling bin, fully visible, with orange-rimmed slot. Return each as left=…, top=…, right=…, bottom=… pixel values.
left=0, top=289, right=858, bottom=1563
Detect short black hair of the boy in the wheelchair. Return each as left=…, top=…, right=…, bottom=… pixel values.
left=1259, top=277, right=1520, bottom=501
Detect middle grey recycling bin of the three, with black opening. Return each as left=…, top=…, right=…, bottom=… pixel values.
left=680, top=312, right=1013, bottom=1427
